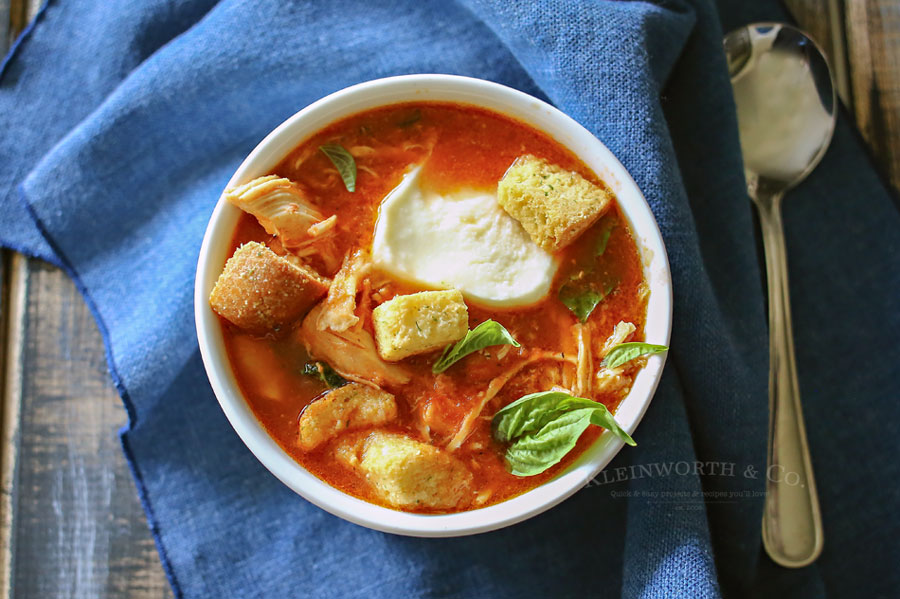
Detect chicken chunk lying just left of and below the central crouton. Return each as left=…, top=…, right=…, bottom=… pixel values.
left=297, top=302, right=410, bottom=386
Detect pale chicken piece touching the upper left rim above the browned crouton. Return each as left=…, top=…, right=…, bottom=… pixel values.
left=224, top=175, right=325, bottom=247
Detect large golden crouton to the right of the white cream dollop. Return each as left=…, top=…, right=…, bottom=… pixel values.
left=497, top=156, right=612, bottom=252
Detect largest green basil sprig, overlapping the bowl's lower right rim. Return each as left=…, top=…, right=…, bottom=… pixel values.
left=492, top=391, right=636, bottom=476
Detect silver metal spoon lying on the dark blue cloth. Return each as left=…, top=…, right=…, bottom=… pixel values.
left=725, top=23, right=837, bottom=568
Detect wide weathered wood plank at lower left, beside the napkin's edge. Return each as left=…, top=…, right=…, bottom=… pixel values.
left=12, top=260, right=171, bottom=599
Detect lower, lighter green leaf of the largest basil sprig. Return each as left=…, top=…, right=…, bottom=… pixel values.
left=506, top=408, right=594, bottom=476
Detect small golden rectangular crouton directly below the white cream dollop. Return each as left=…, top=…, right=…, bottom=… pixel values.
left=372, top=289, right=469, bottom=361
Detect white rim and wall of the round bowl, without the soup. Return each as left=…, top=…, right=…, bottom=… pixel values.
left=194, top=75, right=672, bottom=537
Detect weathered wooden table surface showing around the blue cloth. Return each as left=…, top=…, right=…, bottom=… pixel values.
left=0, top=0, right=900, bottom=599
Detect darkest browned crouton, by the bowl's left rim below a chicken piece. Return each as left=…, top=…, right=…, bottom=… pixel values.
left=209, top=241, right=328, bottom=332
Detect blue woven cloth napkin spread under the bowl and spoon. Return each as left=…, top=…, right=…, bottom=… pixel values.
left=0, top=0, right=900, bottom=598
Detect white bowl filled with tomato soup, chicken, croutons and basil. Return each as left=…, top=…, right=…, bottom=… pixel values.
left=195, top=75, right=671, bottom=536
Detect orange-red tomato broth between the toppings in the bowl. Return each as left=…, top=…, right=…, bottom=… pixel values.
left=221, top=103, right=647, bottom=512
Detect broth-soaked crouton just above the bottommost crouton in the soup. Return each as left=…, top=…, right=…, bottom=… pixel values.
left=297, top=383, right=397, bottom=451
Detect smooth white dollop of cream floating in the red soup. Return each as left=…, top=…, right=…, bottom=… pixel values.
left=372, top=167, right=558, bottom=307
